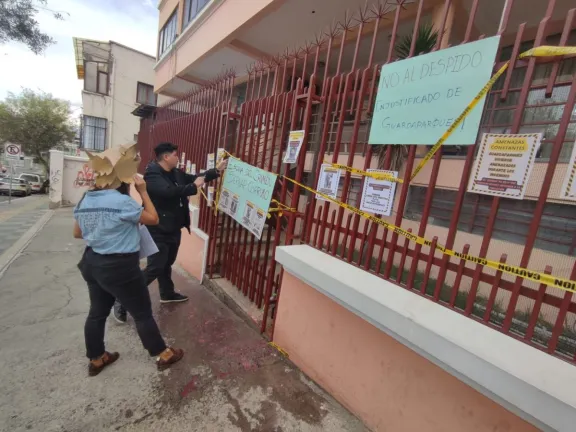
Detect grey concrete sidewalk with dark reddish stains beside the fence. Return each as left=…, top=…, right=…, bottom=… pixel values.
left=0, top=209, right=366, bottom=432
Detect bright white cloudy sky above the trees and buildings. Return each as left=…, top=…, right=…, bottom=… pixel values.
left=0, top=0, right=158, bottom=115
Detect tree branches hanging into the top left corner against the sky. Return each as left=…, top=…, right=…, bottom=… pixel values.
left=0, top=0, right=63, bottom=54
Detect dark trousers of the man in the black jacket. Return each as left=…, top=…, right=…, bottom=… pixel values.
left=144, top=231, right=182, bottom=298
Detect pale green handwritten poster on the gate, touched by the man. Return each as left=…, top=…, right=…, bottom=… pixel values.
left=218, top=158, right=276, bottom=238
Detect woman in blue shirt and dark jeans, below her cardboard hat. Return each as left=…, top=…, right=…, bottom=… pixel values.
left=74, top=175, right=184, bottom=376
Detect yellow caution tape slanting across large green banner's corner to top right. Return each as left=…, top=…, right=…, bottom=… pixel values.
left=410, top=46, right=576, bottom=181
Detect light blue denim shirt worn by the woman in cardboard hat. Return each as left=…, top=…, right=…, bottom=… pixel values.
left=74, top=189, right=142, bottom=255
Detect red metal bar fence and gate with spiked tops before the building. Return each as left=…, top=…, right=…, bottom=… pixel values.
left=139, top=0, right=576, bottom=362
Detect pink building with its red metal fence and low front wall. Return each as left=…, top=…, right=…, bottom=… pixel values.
left=139, top=0, right=576, bottom=431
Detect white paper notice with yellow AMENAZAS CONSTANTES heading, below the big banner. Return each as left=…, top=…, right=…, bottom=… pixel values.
left=468, top=133, right=542, bottom=199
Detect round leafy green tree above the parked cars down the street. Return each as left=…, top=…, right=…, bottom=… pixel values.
left=0, top=89, right=76, bottom=170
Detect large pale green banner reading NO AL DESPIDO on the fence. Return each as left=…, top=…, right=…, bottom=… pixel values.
left=368, top=36, right=500, bottom=145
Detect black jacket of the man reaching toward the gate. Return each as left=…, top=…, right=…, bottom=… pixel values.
left=144, top=162, right=220, bottom=237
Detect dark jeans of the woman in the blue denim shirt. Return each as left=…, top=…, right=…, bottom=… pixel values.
left=78, top=248, right=166, bottom=359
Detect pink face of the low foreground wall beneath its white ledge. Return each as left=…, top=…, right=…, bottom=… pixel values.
left=274, top=272, right=538, bottom=432
